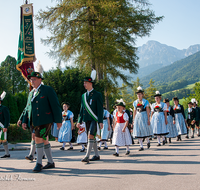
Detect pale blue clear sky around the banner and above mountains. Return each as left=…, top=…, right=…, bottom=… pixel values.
left=0, top=0, right=200, bottom=71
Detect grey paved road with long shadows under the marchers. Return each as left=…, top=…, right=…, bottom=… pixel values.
left=0, top=137, right=200, bottom=190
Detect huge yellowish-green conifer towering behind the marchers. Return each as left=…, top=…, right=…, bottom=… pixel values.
left=36, top=0, right=162, bottom=107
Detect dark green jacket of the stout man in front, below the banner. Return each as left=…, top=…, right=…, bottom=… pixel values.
left=21, top=85, right=62, bottom=127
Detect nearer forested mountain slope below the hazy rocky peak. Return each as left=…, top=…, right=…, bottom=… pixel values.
left=141, top=51, right=200, bottom=87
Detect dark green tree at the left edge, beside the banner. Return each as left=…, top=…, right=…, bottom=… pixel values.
left=1, top=55, right=28, bottom=94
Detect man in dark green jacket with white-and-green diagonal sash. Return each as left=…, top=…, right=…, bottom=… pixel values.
left=77, top=77, right=103, bottom=163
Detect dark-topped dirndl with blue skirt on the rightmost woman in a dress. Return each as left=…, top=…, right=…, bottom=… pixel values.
left=174, top=105, right=187, bottom=135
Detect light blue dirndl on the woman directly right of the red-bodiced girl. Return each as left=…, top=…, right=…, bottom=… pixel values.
left=133, top=99, right=153, bottom=138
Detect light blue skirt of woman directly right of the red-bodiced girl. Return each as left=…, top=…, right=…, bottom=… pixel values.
left=133, top=111, right=153, bottom=138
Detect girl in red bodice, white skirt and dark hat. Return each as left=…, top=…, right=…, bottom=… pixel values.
left=112, top=102, right=132, bottom=156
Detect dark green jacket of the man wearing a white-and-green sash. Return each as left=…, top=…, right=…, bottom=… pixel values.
left=78, top=90, right=103, bottom=123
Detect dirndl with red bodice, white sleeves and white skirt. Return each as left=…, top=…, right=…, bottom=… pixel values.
left=112, top=112, right=132, bottom=146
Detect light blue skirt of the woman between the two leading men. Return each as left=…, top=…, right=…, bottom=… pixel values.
left=58, top=120, right=72, bottom=142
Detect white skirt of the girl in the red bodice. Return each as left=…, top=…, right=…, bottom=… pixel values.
left=112, top=123, right=132, bottom=146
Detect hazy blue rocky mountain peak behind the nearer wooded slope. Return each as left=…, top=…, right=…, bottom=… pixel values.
left=130, top=40, right=200, bottom=79
